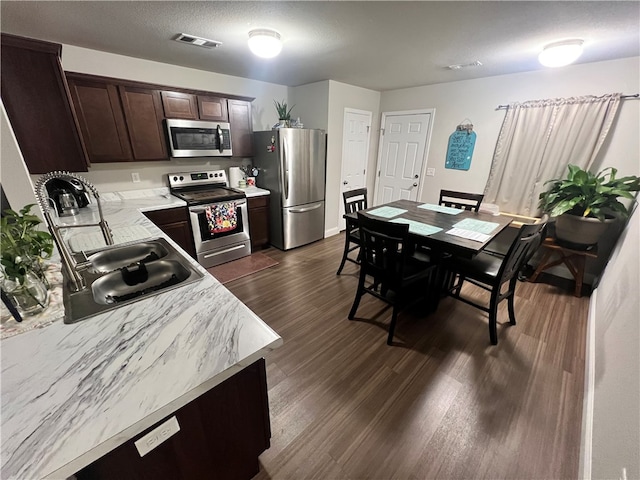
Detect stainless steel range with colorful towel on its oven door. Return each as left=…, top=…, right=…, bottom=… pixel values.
left=168, top=170, right=251, bottom=268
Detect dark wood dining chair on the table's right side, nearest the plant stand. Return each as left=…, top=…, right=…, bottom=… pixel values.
left=445, top=218, right=546, bottom=345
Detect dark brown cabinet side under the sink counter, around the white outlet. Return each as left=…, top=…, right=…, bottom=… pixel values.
left=76, top=359, right=271, bottom=480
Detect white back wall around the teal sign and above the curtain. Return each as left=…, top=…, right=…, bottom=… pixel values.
left=381, top=57, right=640, bottom=206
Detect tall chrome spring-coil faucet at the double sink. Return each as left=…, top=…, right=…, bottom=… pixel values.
left=34, top=171, right=113, bottom=292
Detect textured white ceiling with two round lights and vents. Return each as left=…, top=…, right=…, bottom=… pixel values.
left=0, top=0, right=640, bottom=91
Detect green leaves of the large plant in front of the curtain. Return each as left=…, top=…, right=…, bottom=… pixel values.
left=539, top=165, right=640, bottom=221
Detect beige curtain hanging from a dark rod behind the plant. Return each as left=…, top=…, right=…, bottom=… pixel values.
left=484, top=93, right=621, bottom=216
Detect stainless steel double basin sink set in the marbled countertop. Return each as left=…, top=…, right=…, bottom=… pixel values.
left=63, top=238, right=203, bottom=323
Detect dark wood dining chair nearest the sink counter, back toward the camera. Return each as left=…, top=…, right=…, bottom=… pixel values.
left=349, top=212, right=436, bottom=345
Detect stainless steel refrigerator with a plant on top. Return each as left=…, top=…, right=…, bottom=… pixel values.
left=253, top=128, right=327, bottom=250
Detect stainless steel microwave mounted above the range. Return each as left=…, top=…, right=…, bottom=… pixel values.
left=167, top=118, right=232, bottom=157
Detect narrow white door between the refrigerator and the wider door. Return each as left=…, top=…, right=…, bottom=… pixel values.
left=338, top=108, right=372, bottom=230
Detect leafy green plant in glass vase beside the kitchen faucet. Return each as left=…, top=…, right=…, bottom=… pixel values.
left=0, top=204, right=53, bottom=315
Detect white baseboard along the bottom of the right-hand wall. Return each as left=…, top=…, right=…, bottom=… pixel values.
left=579, top=288, right=598, bottom=480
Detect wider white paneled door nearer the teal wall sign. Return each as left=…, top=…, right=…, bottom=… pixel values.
left=374, top=110, right=434, bottom=205
